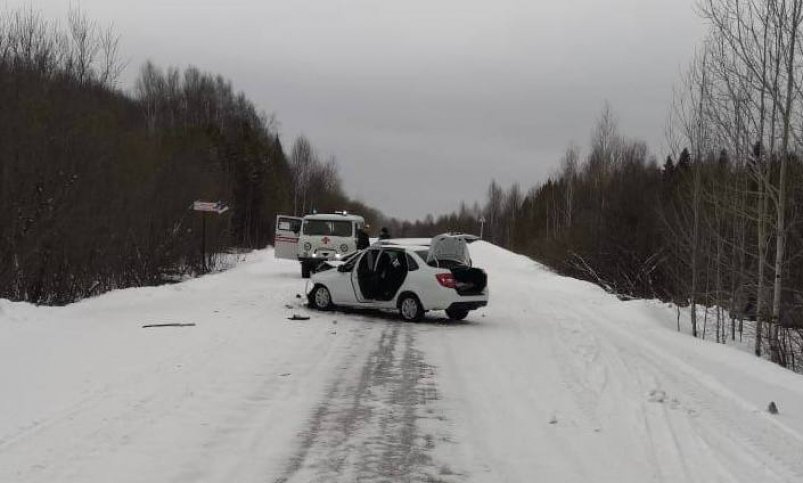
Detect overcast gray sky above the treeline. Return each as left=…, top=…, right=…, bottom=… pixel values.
left=11, top=0, right=703, bottom=218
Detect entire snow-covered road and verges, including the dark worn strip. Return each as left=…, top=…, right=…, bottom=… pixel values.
left=0, top=242, right=803, bottom=483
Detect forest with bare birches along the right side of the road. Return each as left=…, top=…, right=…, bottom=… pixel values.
left=393, top=0, right=803, bottom=370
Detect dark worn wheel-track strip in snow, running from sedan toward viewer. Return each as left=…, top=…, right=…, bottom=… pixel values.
left=276, top=321, right=458, bottom=483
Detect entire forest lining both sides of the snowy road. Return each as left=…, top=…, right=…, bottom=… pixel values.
left=6, top=0, right=803, bottom=370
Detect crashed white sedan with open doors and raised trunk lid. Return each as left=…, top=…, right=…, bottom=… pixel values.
left=307, top=235, right=488, bottom=321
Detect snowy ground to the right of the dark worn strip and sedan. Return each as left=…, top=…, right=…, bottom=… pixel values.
left=419, top=243, right=803, bottom=482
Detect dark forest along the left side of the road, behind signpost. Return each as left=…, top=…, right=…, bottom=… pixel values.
left=0, top=8, right=379, bottom=304
